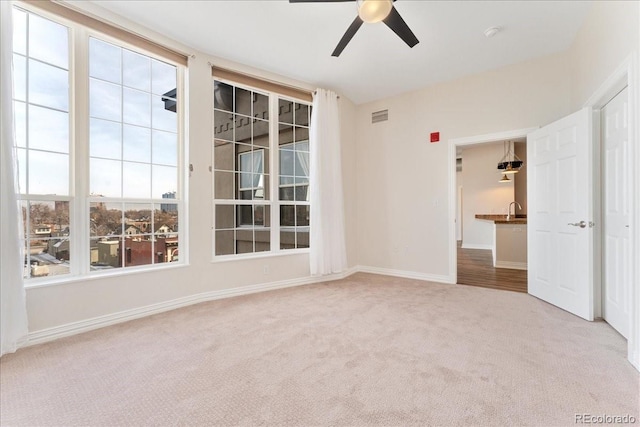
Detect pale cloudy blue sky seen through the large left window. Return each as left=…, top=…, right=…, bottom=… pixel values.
left=13, top=7, right=178, bottom=199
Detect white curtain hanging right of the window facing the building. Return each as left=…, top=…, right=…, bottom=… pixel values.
left=309, top=89, right=347, bottom=276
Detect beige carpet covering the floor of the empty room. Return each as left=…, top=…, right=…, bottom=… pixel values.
left=0, top=274, right=640, bottom=426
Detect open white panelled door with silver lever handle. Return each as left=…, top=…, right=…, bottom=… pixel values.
left=527, top=108, right=594, bottom=320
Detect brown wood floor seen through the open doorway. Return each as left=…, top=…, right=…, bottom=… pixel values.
left=458, top=242, right=527, bottom=293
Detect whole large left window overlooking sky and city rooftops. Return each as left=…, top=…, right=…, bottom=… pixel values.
left=13, top=2, right=184, bottom=283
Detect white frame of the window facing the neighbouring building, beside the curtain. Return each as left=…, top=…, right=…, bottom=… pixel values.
left=210, top=76, right=311, bottom=263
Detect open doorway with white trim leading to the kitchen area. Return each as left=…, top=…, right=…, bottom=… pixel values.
left=450, top=128, right=533, bottom=293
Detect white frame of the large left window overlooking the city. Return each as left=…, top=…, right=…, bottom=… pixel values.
left=14, top=2, right=189, bottom=288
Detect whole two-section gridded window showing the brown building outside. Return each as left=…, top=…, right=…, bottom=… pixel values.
left=213, top=79, right=310, bottom=256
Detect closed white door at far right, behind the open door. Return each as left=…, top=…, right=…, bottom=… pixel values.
left=601, top=89, right=631, bottom=338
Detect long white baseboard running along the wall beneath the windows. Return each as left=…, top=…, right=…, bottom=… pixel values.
left=27, top=267, right=358, bottom=347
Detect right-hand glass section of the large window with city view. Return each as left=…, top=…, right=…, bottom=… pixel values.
left=89, top=37, right=179, bottom=269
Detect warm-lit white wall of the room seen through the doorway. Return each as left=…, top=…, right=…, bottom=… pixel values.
left=462, top=142, right=514, bottom=249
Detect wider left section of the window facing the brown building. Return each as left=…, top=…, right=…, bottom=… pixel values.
left=213, top=81, right=271, bottom=255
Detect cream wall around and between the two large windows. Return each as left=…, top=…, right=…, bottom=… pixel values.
left=26, top=2, right=357, bottom=332
